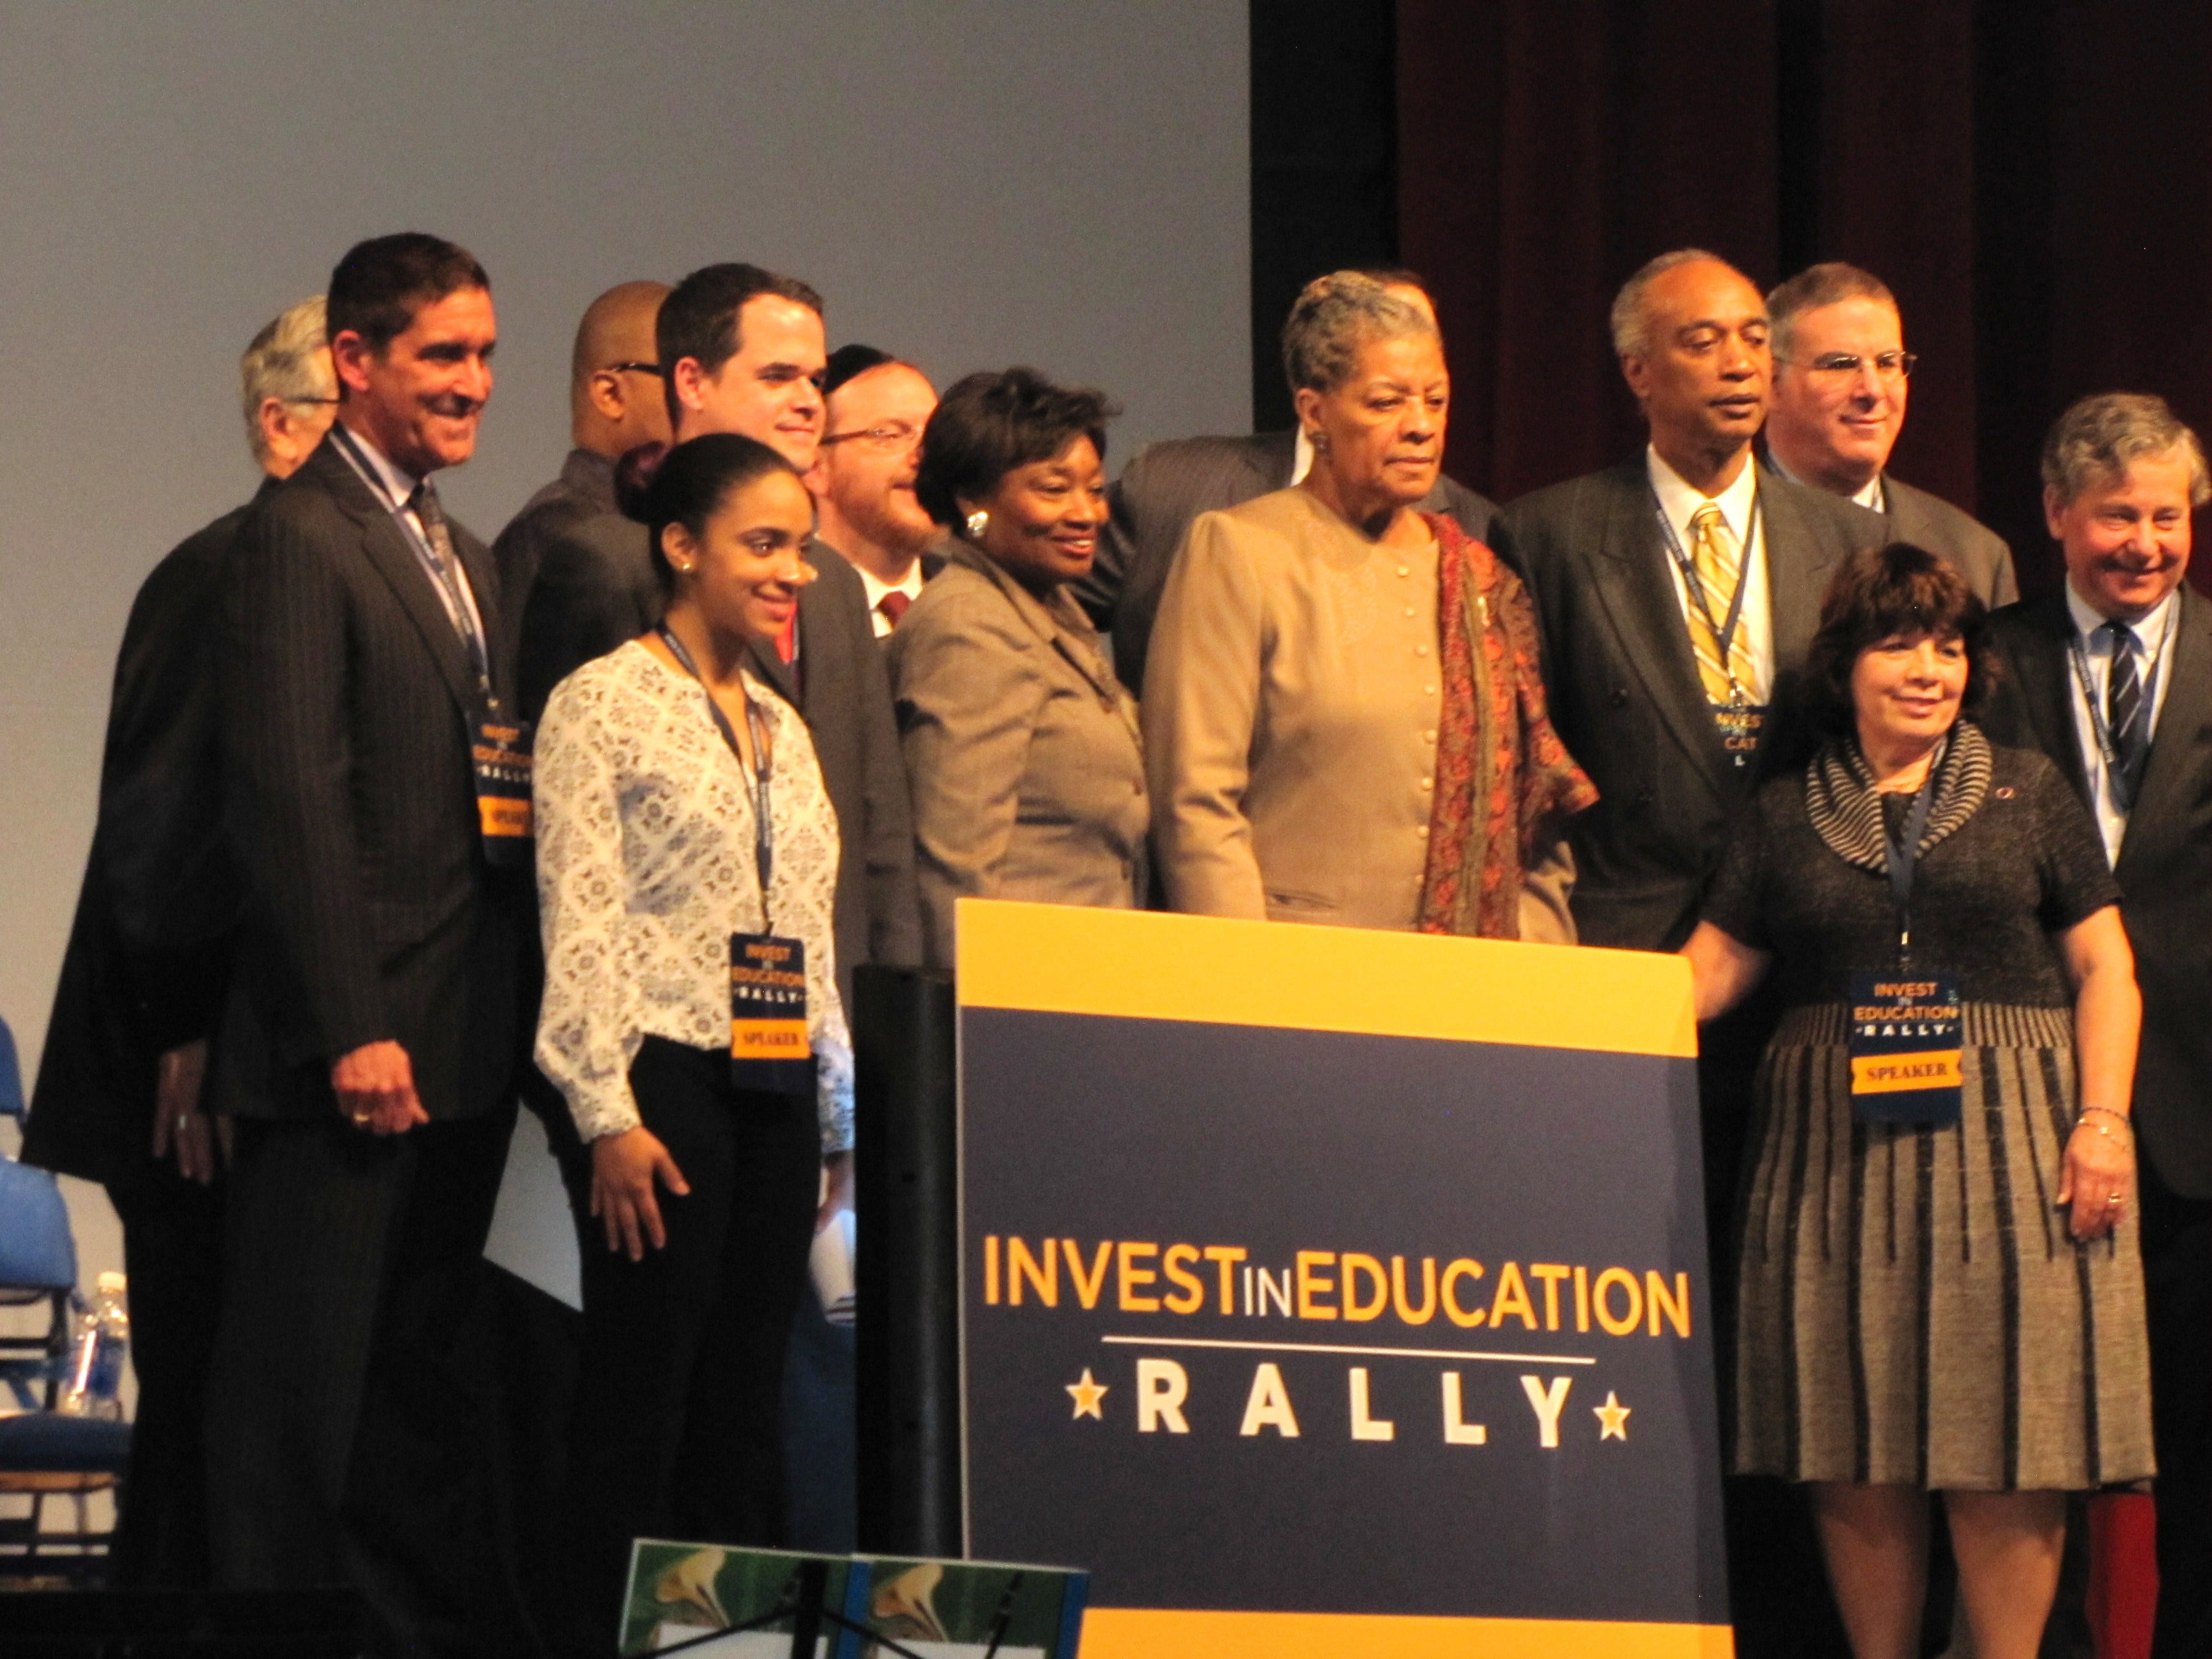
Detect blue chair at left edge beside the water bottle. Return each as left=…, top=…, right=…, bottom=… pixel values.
left=0, top=1020, right=131, bottom=1584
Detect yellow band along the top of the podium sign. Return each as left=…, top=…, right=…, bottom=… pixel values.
left=956, top=898, right=1697, bottom=1057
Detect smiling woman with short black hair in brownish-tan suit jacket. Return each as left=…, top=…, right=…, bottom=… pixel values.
left=889, top=369, right=1148, bottom=967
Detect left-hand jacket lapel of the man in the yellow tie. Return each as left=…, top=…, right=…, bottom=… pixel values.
left=1593, top=469, right=1728, bottom=796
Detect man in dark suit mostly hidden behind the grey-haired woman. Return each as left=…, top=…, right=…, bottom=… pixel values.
left=1068, top=270, right=1498, bottom=686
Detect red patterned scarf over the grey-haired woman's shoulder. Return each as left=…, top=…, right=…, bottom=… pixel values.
left=1418, top=513, right=1597, bottom=938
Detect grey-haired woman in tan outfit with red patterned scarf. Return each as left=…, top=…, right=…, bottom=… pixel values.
left=1144, top=272, right=1597, bottom=945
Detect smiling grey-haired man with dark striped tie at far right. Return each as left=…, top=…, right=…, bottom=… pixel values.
left=1982, top=392, right=2212, bottom=1659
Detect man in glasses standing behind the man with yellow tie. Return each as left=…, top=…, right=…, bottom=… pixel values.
left=1761, top=263, right=2020, bottom=608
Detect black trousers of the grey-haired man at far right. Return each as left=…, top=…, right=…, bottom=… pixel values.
left=2137, top=1159, right=2212, bottom=1659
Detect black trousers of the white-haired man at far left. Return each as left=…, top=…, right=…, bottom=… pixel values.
left=108, top=1159, right=226, bottom=1590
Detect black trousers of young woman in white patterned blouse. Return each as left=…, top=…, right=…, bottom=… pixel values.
left=568, top=1037, right=821, bottom=1655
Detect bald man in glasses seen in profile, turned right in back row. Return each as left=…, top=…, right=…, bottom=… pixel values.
left=491, top=281, right=668, bottom=686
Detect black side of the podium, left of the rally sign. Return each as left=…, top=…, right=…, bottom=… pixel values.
left=852, top=967, right=964, bottom=1557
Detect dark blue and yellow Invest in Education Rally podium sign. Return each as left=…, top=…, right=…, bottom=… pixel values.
left=958, top=900, right=1734, bottom=1659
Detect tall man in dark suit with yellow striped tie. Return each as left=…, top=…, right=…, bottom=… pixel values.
left=1498, top=248, right=1887, bottom=1659
